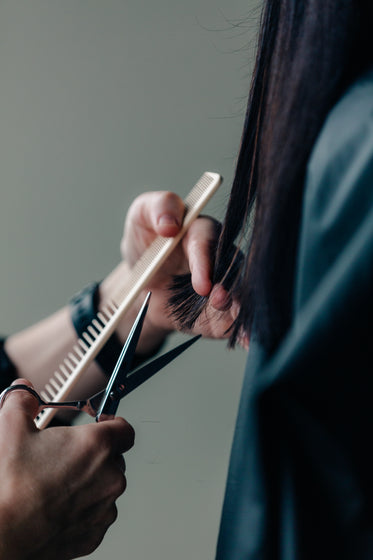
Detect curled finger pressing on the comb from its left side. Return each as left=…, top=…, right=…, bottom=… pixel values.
left=131, top=191, right=185, bottom=237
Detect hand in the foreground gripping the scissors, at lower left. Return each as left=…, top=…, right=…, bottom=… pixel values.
left=0, top=380, right=134, bottom=560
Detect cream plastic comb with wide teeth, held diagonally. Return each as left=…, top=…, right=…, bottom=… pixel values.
left=35, top=172, right=222, bottom=429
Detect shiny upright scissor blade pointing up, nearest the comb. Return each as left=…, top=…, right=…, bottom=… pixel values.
left=96, top=292, right=151, bottom=421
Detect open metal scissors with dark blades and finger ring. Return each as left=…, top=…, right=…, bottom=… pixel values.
left=0, top=292, right=201, bottom=422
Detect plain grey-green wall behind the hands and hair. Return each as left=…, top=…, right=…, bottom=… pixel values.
left=0, top=0, right=258, bottom=560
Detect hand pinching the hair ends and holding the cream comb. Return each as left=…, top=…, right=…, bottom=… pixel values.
left=121, top=191, right=238, bottom=344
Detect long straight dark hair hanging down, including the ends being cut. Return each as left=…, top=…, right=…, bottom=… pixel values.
left=173, top=0, right=372, bottom=351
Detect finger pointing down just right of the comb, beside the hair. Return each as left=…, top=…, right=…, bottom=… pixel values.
left=183, top=218, right=219, bottom=296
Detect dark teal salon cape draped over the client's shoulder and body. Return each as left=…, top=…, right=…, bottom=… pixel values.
left=217, top=71, right=373, bottom=560
